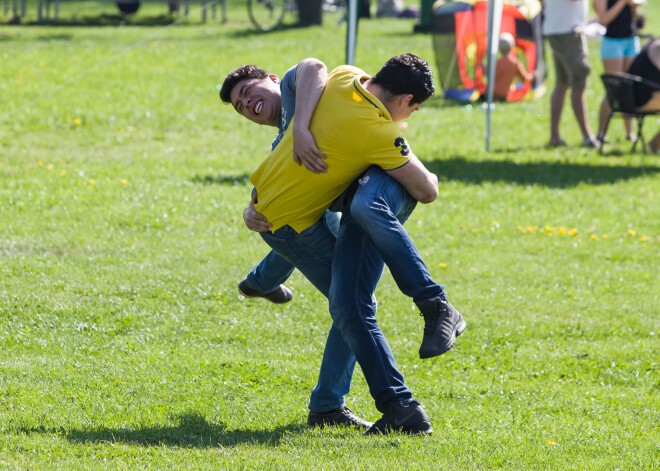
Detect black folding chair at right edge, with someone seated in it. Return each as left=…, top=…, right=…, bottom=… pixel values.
left=600, top=73, right=660, bottom=154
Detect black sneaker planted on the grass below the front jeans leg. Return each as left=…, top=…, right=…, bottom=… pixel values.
left=365, top=400, right=433, bottom=435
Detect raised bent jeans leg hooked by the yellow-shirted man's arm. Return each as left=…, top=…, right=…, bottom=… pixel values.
left=350, top=166, right=447, bottom=303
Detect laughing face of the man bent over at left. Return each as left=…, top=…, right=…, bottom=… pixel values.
left=229, top=75, right=282, bottom=126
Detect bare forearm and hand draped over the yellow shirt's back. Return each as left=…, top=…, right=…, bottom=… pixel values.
left=293, top=58, right=328, bottom=173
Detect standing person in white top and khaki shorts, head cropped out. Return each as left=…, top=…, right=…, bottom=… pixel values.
left=542, top=0, right=598, bottom=147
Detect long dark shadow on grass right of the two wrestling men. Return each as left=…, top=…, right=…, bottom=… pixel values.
left=424, top=157, right=660, bottom=188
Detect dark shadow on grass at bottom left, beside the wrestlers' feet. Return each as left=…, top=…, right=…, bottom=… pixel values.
left=19, top=412, right=303, bottom=448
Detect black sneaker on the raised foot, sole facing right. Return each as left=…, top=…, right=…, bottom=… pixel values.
left=417, top=297, right=467, bottom=358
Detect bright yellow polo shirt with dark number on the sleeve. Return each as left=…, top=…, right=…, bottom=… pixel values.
left=250, top=66, right=410, bottom=232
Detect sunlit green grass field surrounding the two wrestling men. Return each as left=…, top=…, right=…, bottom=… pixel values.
left=0, top=0, right=660, bottom=470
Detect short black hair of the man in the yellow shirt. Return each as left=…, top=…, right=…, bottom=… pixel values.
left=371, top=53, right=435, bottom=105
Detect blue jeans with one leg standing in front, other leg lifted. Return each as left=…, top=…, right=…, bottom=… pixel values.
left=329, top=167, right=436, bottom=412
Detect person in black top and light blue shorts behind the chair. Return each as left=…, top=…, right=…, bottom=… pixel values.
left=594, top=0, right=640, bottom=144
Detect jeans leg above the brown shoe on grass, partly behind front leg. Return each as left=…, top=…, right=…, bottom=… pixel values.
left=261, top=218, right=355, bottom=412
